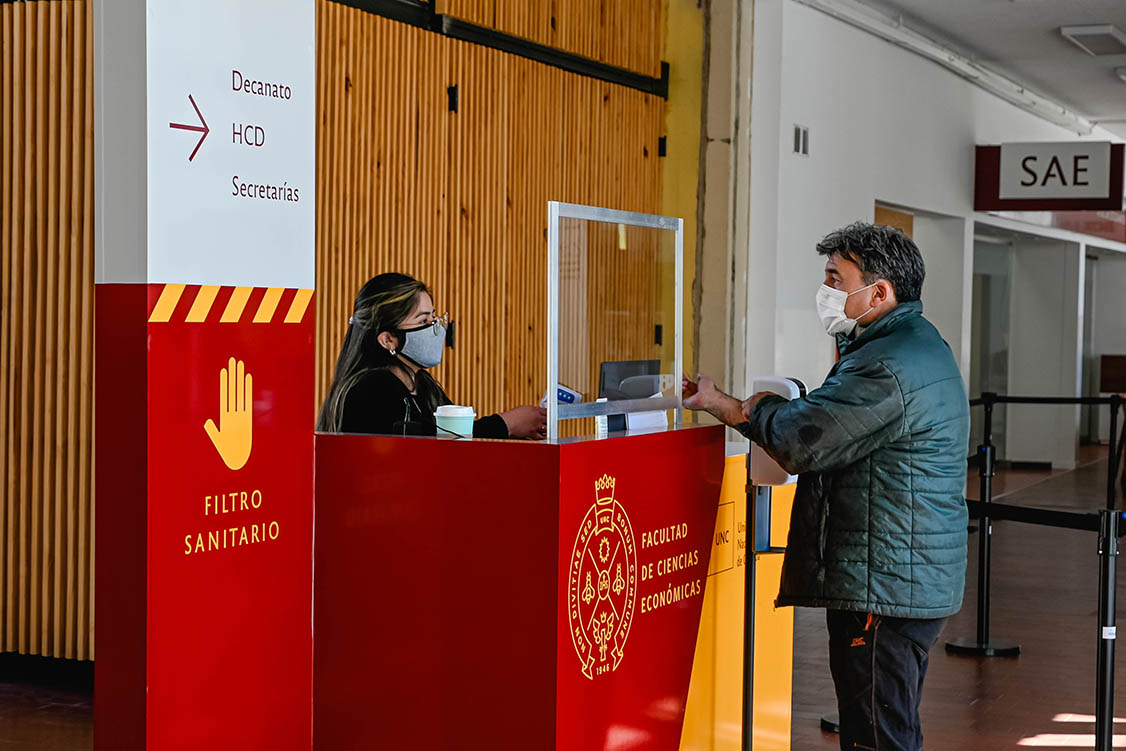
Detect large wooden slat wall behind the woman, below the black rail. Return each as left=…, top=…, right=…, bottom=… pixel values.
left=318, top=1, right=664, bottom=414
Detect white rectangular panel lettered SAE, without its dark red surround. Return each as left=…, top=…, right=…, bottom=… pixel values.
left=999, top=141, right=1110, bottom=199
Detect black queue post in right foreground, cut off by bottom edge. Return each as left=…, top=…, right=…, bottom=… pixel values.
left=1094, top=509, right=1121, bottom=751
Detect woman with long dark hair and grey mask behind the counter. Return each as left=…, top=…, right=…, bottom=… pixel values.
left=316, top=274, right=547, bottom=440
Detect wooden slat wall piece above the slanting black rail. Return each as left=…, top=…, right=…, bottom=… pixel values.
left=436, top=0, right=664, bottom=77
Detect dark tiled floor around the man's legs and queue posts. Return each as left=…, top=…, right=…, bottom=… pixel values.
left=793, top=455, right=1126, bottom=751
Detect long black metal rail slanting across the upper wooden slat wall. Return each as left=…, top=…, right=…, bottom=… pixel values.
left=333, top=0, right=669, bottom=99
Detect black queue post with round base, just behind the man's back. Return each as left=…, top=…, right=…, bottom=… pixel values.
left=946, top=392, right=1020, bottom=658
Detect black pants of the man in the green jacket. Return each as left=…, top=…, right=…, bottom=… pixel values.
left=825, top=610, right=946, bottom=751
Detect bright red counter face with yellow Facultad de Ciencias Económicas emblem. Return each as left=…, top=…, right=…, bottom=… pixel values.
left=555, top=428, right=724, bottom=751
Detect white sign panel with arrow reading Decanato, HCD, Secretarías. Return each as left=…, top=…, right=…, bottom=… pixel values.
left=146, top=0, right=316, bottom=288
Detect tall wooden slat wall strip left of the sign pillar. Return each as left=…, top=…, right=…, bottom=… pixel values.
left=0, top=0, right=93, bottom=659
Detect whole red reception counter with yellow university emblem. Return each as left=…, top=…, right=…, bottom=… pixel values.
left=313, top=427, right=724, bottom=751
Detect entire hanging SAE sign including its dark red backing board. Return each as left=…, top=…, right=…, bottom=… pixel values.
left=974, top=141, right=1123, bottom=211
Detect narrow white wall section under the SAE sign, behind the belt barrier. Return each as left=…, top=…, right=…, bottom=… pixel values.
left=1004, top=240, right=1085, bottom=468
